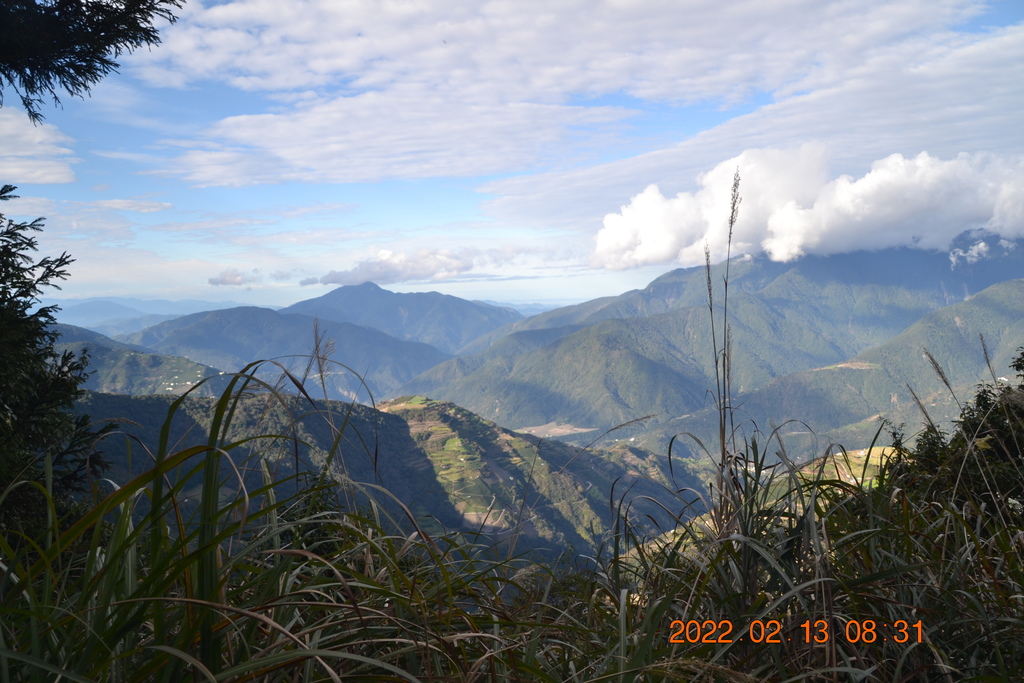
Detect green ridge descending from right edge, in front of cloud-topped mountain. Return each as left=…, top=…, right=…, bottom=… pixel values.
left=652, top=280, right=1024, bottom=458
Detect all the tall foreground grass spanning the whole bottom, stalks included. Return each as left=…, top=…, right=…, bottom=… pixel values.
left=0, top=205, right=1024, bottom=683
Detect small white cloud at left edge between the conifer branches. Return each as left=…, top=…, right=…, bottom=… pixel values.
left=0, top=106, right=78, bottom=184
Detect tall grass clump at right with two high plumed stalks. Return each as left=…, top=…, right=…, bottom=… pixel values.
left=609, top=173, right=1024, bottom=681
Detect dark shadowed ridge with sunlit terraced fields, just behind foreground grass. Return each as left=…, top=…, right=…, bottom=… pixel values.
left=79, top=392, right=700, bottom=554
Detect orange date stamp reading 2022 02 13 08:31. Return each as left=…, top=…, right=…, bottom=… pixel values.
left=669, top=618, right=924, bottom=645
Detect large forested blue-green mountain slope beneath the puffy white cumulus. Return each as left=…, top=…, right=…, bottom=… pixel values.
left=401, top=242, right=1024, bottom=429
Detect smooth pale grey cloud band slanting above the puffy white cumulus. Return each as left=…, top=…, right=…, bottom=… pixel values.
left=481, top=26, right=1024, bottom=235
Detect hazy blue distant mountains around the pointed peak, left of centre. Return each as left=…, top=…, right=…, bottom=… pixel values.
left=48, top=284, right=522, bottom=401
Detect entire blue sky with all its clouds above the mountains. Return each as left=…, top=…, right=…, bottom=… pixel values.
left=0, top=0, right=1024, bottom=305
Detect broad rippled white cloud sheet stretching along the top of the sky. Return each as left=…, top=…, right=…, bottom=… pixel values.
left=128, top=0, right=982, bottom=185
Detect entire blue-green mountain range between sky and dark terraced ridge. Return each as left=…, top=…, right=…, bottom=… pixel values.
left=60, top=236, right=1024, bottom=532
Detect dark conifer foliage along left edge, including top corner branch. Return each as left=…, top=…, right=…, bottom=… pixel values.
left=0, top=0, right=182, bottom=532
